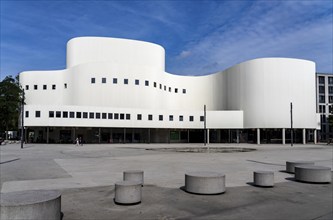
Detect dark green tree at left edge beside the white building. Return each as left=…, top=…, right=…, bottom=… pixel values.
left=0, top=76, right=23, bottom=139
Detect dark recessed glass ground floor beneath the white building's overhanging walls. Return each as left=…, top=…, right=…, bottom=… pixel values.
left=24, top=127, right=317, bottom=144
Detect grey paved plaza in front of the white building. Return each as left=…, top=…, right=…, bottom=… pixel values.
left=0, top=144, right=333, bottom=220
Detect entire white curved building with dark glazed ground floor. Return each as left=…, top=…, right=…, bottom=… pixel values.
left=20, top=37, right=320, bottom=143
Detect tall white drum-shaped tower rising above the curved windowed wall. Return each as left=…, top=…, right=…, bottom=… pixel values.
left=67, top=37, right=165, bottom=73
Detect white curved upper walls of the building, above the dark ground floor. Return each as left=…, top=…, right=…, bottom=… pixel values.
left=20, top=37, right=317, bottom=128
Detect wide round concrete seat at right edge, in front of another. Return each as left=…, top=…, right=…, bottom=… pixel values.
left=295, top=165, right=332, bottom=183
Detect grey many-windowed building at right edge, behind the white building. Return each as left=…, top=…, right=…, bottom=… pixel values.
left=316, top=73, right=333, bottom=142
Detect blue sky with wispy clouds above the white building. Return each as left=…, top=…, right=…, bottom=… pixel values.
left=0, top=0, right=333, bottom=79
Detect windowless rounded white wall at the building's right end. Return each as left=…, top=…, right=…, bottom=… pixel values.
left=225, top=58, right=317, bottom=128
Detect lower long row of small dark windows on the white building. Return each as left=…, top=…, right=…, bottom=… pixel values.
left=25, top=111, right=204, bottom=121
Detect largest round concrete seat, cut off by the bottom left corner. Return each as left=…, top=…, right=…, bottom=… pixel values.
left=0, top=190, right=61, bottom=220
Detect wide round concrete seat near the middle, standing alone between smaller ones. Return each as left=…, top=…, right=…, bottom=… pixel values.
left=185, top=172, right=226, bottom=195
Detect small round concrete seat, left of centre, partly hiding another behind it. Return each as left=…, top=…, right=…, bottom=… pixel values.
left=114, top=180, right=142, bottom=205
